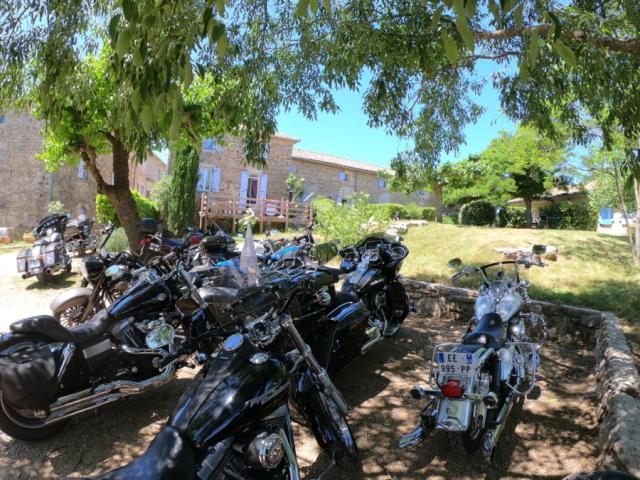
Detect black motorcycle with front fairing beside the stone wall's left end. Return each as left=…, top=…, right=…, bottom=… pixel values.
left=339, top=235, right=414, bottom=340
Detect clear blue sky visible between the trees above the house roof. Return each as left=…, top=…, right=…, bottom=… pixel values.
left=278, top=61, right=515, bottom=166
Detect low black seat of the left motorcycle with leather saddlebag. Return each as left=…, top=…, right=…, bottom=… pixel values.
left=9, top=310, right=111, bottom=344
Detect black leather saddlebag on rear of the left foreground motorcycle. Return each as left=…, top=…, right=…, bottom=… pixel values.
left=0, top=346, right=58, bottom=410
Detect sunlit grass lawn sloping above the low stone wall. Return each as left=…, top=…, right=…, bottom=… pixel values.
left=402, top=223, right=640, bottom=327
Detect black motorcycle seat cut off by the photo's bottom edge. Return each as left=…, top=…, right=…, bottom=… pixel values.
left=85, top=426, right=196, bottom=480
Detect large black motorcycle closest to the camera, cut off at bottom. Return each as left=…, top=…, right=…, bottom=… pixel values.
left=83, top=264, right=360, bottom=480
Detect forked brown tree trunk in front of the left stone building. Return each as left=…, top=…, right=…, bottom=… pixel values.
left=81, top=132, right=141, bottom=254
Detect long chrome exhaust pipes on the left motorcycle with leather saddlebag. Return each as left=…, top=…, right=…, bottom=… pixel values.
left=43, top=365, right=175, bottom=425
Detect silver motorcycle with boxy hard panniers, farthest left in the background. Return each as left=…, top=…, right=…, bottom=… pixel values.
left=17, top=215, right=71, bottom=282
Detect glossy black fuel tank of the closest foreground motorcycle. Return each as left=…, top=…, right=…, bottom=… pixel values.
left=169, top=334, right=289, bottom=448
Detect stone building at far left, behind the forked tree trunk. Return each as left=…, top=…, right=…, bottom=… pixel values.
left=0, top=112, right=166, bottom=234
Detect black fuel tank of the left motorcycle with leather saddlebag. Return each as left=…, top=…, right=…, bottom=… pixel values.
left=109, top=281, right=171, bottom=319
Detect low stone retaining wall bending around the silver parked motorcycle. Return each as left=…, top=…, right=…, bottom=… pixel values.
left=403, top=279, right=640, bottom=477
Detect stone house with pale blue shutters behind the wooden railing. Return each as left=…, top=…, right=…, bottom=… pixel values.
left=192, top=134, right=435, bottom=206
